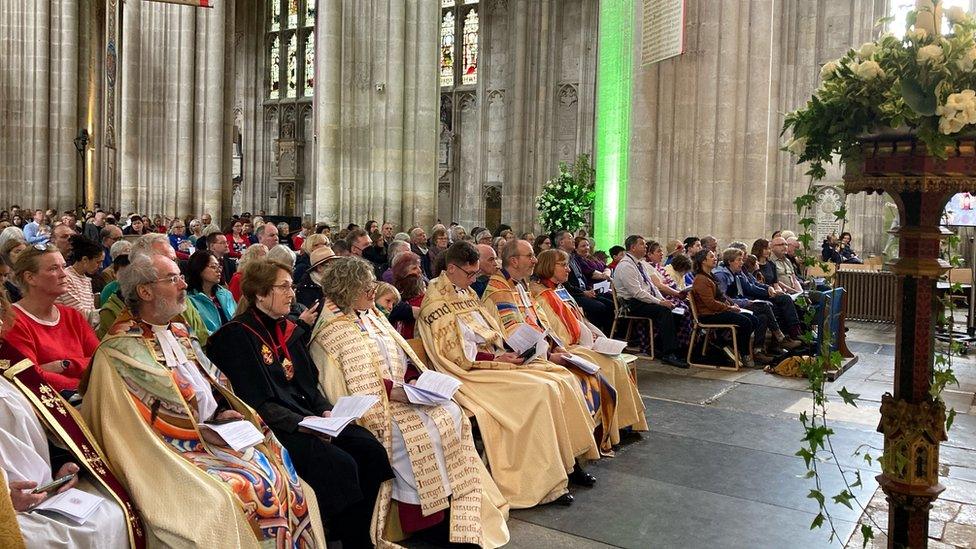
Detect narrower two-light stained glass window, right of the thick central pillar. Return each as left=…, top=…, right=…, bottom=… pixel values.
left=440, top=0, right=481, bottom=88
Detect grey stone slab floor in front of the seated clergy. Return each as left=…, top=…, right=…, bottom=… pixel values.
left=407, top=323, right=976, bottom=549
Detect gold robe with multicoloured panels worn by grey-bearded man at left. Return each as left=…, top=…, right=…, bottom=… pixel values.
left=82, top=318, right=325, bottom=548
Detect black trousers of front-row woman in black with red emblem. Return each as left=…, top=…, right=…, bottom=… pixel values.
left=275, top=425, right=393, bottom=549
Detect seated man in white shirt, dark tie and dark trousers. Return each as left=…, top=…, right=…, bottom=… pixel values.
left=613, top=234, right=688, bottom=368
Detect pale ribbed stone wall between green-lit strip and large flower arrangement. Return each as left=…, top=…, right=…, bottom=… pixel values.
left=627, top=0, right=886, bottom=252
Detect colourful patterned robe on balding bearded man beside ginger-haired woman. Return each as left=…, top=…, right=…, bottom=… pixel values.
left=481, top=270, right=617, bottom=452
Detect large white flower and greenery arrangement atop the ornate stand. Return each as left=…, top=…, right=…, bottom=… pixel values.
left=781, top=9, right=976, bottom=176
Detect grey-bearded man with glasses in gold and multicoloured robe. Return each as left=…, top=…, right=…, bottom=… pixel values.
left=81, top=253, right=325, bottom=548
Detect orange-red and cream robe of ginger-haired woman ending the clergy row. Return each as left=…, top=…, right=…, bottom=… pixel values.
left=529, top=281, right=647, bottom=438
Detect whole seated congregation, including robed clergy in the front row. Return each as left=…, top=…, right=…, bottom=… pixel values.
left=0, top=210, right=844, bottom=549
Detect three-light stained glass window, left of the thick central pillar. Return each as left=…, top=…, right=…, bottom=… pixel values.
left=265, top=0, right=318, bottom=101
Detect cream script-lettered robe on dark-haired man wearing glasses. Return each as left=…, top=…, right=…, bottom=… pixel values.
left=417, top=274, right=599, bottom=508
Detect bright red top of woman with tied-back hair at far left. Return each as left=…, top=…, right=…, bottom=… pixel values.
left=0, top=304, right=98, bottom=391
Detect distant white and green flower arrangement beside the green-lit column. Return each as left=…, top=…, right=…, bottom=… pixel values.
left=535, top=154, right=596, bottom=232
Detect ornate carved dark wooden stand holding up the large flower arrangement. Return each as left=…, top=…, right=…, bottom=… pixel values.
left=844, top=134, right=964, bottom=549
